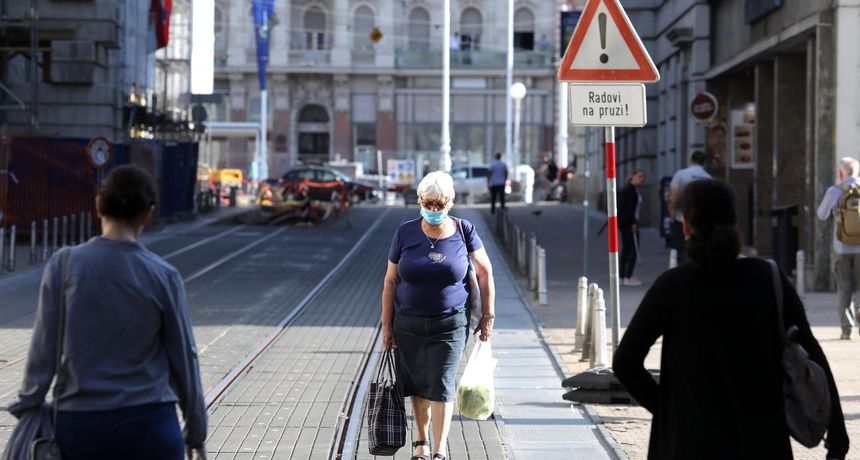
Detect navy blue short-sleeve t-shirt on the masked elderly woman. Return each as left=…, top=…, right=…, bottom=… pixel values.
left=388, top=218, right=484, bottom=317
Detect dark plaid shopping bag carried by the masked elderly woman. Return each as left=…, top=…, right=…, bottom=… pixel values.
left=367, top=350, right=406, bottom=455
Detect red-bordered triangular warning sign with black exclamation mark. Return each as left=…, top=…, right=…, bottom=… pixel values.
left=558, top=0, right=660, bottom=82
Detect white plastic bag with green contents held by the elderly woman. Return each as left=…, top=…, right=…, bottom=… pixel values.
left=457, top=340, right=496, bottom=420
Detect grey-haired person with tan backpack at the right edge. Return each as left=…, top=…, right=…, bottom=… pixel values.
left=818, top=157, right=860, bottom=340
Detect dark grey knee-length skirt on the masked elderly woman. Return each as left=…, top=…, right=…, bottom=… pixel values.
left=394, top=308, right=469, bottom=402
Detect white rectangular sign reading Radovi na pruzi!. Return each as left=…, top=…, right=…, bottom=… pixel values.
left=568, top=83, right=648, bottom=127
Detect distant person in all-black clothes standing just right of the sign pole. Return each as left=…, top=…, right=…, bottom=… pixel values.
left=618, top=169, right=645, bottom=286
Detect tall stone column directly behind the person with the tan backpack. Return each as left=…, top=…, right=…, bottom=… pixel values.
left=814, top=11, right=837, bottom=291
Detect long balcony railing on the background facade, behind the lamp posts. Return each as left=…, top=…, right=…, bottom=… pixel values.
left=396, top=49, right=554, bottom=69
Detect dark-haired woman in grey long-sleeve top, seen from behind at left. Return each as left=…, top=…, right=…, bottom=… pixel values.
left=9, top=166, right=206, bottom=460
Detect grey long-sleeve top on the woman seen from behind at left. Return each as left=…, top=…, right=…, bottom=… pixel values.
left=9, top=237, right=206, bottom=447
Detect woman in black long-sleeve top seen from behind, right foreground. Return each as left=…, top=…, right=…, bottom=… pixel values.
left=613, top=180, right=848, bottom=460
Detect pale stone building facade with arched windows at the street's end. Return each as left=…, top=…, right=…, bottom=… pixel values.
left=210, top=0, right=558, bottom=176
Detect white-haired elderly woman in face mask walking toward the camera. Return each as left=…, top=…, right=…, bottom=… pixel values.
left=382, top=172, right=495, bottom=460
